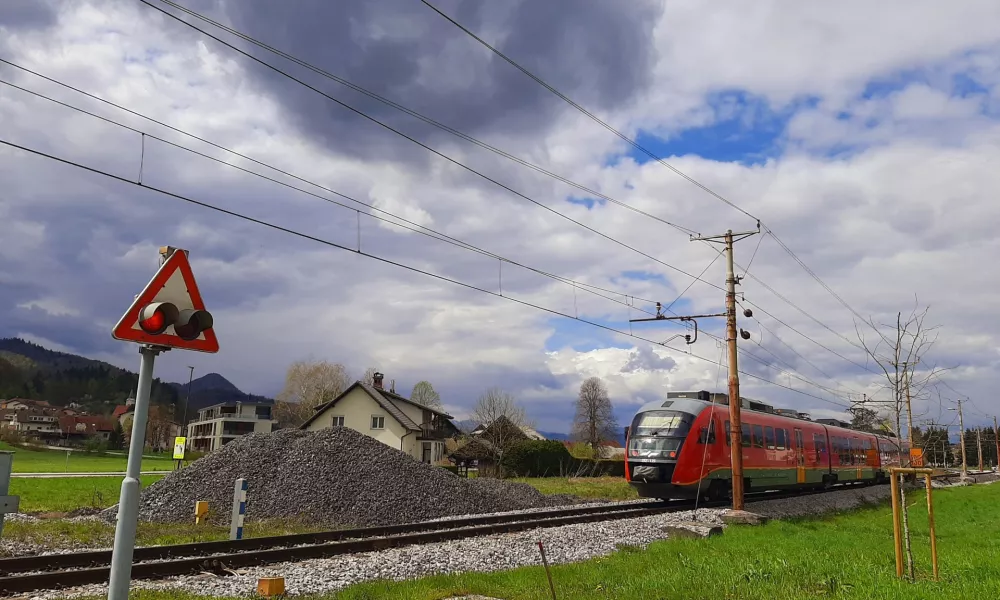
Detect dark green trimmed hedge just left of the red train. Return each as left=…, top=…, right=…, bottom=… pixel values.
left=502, top=440, right=625, bottom=477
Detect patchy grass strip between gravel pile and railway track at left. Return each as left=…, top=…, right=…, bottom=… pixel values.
left=3, top=507, right=328, bottom=549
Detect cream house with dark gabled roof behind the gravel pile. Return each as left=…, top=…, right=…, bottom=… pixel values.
left=300, top=373, right=460, bottom=464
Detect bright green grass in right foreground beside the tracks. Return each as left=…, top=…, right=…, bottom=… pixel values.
left=84, top=484, right=1000, bottom=600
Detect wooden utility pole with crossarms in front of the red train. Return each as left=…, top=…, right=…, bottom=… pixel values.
left=629, top=222, right=760, bottom=510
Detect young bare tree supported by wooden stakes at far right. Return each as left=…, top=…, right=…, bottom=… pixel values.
left=855, top=306, right=942, bottom=580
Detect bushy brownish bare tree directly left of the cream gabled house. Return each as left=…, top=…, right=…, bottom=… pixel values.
left=274, top=360, right=350, bottom=426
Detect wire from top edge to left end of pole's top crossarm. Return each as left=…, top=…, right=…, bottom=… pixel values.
left=148, top=0, right=697, bottom=235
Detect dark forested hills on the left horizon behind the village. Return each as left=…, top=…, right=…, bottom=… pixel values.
left=0, top=338, right=270, bottom=416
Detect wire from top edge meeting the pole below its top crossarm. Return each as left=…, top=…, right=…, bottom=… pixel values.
left=139, top=0, right=723, bottom=290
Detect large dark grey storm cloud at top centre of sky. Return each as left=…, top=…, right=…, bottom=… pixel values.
left=158, top=0, right=660, bottom=158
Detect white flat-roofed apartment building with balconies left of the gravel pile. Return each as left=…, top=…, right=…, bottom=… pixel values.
left=186, top=401, right=277, bottom=452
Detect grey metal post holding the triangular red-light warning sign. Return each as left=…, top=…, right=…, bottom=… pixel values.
left=108, top=346, right=161, bottom=600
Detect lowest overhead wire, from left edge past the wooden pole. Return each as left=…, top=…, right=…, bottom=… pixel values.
left=0, top=138, right=852, bottom=402
